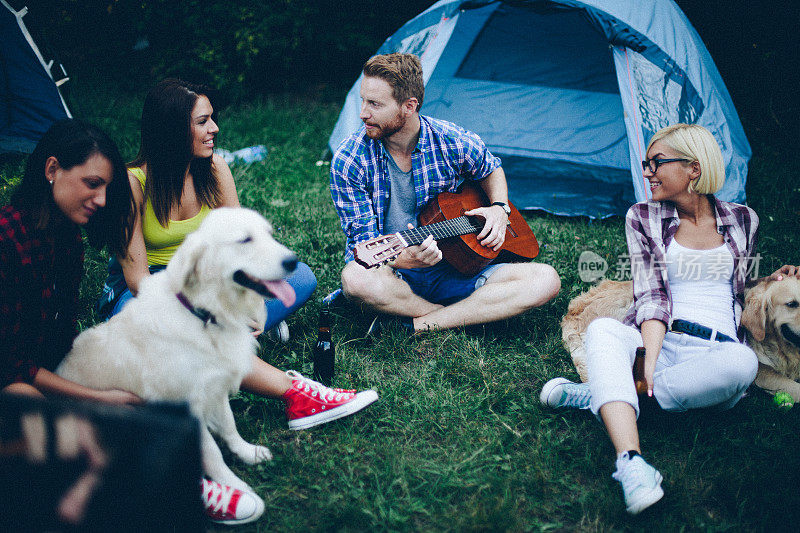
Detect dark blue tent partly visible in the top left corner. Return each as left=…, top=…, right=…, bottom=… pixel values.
left=0, top=0, right=71, bottom=154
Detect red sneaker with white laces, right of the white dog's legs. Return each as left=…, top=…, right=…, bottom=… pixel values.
left=283, top=370, right=378, bottom=429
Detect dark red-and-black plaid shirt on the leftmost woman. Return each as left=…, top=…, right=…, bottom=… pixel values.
left=0, top=205, right=83, bottom=388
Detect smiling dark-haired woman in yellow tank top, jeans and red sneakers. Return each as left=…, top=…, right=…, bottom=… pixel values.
left=97, top=80, right=374, bottom=474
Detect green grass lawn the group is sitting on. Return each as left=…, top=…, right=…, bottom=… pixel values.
left=0, top=76, right=800, bottom=532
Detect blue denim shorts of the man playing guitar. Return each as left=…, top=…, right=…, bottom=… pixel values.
left=395, top=260, right=502, bottom=305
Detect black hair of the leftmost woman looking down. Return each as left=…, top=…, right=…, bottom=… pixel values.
left=11, top=119, right=136, bottom=256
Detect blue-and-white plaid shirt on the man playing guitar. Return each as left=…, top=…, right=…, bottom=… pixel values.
left=331, top=115, right=500, bottom=261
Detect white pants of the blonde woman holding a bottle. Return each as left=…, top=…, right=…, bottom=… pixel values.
left=586, top=318, right=758, bottom=417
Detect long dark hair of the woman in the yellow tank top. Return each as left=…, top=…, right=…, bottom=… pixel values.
left=130, top=79, right=221, bottom=227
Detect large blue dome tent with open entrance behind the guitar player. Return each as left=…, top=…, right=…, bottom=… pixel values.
left=329, top=0, right=751, bottom=217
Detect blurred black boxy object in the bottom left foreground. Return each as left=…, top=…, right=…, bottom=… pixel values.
left=0, top=394, right=206, bottom=533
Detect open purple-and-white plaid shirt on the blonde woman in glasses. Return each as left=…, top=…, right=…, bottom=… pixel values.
left=625, top=196, right=758, bottom=327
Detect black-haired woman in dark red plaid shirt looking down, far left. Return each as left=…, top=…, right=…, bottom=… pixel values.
left=0, top=120, right=141, bottom=404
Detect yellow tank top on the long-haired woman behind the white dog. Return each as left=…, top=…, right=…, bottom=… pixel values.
left=128, top=167, right=211, bottom=265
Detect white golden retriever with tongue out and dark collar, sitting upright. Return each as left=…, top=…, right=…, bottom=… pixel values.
left=57, top=208, right=297, bottom=490
